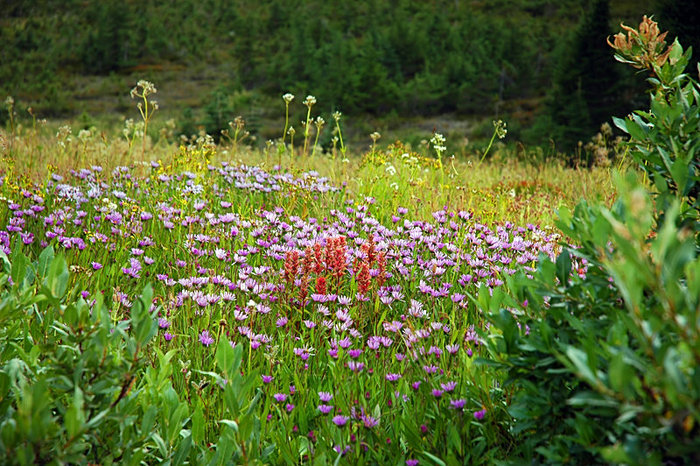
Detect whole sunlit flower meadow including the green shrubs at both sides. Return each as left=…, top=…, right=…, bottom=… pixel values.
left=0, top=16, right=700, bottom=465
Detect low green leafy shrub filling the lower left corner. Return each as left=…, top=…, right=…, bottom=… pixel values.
left=0, top=245, right=274, bottom=464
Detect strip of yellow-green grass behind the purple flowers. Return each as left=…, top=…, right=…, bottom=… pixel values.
left=0, top=115, right=615, bottom=225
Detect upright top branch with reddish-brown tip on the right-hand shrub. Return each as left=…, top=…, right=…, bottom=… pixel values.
left=608, top=16, right=700, bottom=234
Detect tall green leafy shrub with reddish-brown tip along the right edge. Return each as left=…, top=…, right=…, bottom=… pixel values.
left=480, top=18, right=700, bottom=464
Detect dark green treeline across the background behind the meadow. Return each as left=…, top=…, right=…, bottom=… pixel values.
left=0, top=0, right=700, bottom=146
